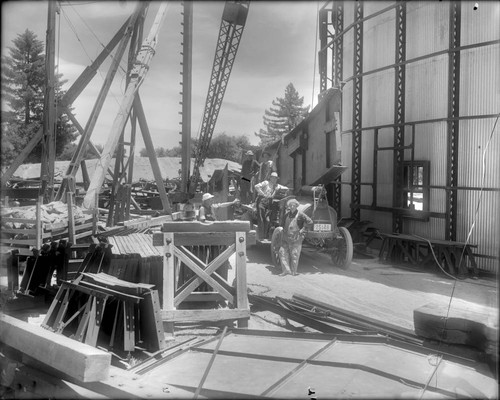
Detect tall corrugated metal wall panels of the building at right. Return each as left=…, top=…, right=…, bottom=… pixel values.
left=326, top=1, right=500, bottom=271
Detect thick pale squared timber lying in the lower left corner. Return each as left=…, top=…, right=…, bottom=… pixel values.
left=0, top=315, right=111, bottom=382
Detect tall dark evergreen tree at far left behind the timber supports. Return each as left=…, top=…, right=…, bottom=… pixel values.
left=2, top=29, right=77, bottom=166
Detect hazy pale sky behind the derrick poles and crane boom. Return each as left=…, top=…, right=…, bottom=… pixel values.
left=1, top=0, right=323, bottom=151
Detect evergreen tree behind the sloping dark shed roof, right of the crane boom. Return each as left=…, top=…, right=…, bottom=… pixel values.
left=255, top=83, right=309, bottom=146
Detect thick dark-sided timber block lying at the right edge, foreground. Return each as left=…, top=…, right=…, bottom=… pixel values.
left=413, top=303, right=498, bottom=350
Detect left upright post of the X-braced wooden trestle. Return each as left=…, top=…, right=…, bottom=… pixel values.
left=162, top=232, right=175, bottom=336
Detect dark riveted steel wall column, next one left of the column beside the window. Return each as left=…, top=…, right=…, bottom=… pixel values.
left=351, top=1, right=363, bottom=220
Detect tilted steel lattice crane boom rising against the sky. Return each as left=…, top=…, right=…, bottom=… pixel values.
left=189, top=1, right=250, bottom=194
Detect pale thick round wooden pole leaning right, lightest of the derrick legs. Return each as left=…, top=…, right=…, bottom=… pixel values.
left=83, top=2, right=167, bottom=208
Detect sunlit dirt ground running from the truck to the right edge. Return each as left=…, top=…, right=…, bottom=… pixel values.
left=241, top=245, right=498, bottom=330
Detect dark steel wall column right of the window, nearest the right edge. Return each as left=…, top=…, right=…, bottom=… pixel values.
left=445, top=1, right=461, bottom=240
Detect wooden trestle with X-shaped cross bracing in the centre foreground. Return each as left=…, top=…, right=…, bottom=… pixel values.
left=153, top=221, right=250, bottom=334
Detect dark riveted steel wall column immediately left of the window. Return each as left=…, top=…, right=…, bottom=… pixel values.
left=392, top=1, right=406, bottom=233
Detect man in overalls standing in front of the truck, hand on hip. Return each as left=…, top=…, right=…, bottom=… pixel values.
left=279, top=199, right=313, bottom=276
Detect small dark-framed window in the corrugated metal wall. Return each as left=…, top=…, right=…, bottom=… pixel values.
left=403, top=161, right=429, bottom=216
